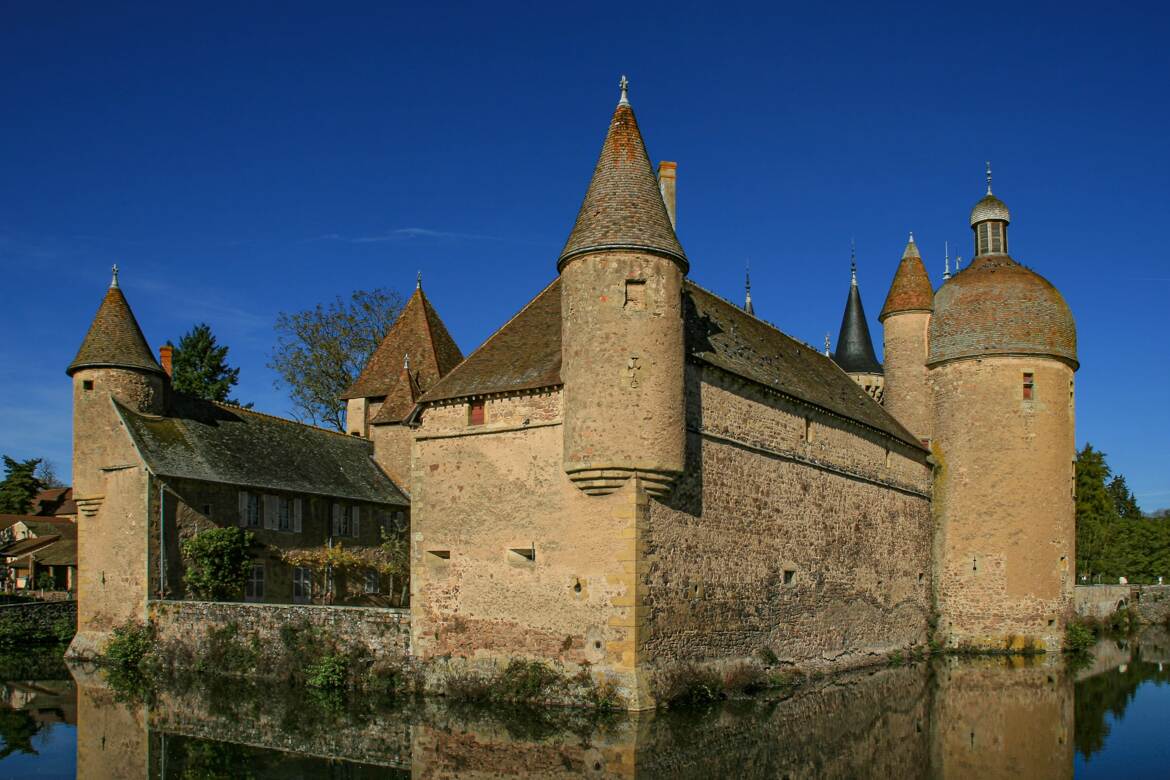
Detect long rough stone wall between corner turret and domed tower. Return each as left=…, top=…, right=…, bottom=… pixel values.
left=641, top=366, right=931, bottom=668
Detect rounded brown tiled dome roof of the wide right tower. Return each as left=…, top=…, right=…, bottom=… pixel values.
left=927, top=254, right=1078, bottom=367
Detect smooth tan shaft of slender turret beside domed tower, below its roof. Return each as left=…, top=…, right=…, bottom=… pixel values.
left=882, top=311, right=931, bottom=439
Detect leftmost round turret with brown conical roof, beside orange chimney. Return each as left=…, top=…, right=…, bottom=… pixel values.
left=66, top=265, right=167, bottom=499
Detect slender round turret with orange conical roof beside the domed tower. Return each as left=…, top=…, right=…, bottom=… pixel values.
left=878, top=233, right=935, bottom=443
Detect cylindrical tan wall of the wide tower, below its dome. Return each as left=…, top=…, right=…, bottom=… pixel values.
left=930, top=357, right=1076, bottom=650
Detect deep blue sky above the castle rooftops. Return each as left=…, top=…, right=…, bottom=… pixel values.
left=0, top=1, right=1170, bottom=509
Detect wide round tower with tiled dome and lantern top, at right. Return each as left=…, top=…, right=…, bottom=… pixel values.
left=927, top=166, right=1078, bottom=650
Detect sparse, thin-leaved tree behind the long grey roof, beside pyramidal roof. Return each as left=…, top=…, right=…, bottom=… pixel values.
left=268, top=289, right=402, bottom=432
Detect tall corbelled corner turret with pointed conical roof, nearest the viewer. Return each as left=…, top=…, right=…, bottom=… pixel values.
left=557, top=78, right=687, bottom=496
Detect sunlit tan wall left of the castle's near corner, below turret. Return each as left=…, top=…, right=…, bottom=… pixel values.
left=411, top=392, right=645, bottom=700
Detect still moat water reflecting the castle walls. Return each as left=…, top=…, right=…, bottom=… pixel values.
left=0, top=628, right=1170, bottom=780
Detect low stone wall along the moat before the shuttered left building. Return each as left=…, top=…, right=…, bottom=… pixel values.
left=150, top=601, right=411, bottom=663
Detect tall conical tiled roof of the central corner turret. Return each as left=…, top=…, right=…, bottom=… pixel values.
left=557, top=103, right=687, bottom=272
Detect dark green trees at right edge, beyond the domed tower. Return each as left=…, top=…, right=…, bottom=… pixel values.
left=1076, top=444, right=1170, bottom=582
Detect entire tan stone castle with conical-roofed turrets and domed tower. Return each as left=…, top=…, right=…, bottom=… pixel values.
left=68, top=84, right=1078, bottom=709
